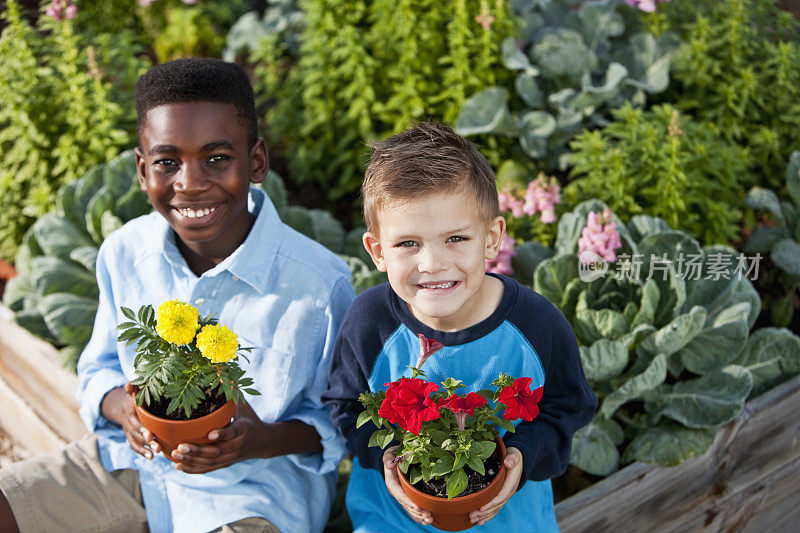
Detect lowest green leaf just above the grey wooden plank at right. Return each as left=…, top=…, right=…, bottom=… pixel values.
left=622, top=422, right=717, bottom=466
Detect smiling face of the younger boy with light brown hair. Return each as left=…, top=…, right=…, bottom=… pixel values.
left=363, top=194, right=505, bottom=331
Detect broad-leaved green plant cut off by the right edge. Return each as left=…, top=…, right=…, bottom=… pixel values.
left=744, top=151, right=800, bottom=326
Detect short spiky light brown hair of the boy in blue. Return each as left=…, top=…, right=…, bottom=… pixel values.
left=361, top=122, right=500, bottom=232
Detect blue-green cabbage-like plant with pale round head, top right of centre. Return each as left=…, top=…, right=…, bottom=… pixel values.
left=456, top=0, right=675, bottom=170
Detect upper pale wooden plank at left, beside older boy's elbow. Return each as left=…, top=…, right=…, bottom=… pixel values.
left=0, top=305, right=87, bottom=442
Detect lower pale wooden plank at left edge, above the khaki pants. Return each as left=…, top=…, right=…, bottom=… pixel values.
left=0, top=372, right=66, bottom=455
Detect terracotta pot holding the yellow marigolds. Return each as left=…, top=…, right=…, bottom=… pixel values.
left=134, top=398, right=236, bottom=461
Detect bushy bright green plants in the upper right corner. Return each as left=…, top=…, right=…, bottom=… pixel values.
left=660, top=0, right=800, bottom=190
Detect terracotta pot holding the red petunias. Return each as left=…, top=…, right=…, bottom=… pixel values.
left=397, top=437, right=506, bottom=531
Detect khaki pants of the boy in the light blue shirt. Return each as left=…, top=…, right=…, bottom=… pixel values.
left=0, top=436, right=279, bottom=533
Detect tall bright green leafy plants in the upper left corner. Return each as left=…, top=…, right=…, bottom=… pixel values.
left=0, top=0, right=147, bottom=259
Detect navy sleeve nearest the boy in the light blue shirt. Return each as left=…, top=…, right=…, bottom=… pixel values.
left=322, top=284, right=397, bottom=474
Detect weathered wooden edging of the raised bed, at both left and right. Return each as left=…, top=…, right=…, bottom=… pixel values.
left=0, top=306, right=800, bottom=533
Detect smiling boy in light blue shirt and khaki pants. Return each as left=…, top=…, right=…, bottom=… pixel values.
left=0, top=59, right=354, bottom=533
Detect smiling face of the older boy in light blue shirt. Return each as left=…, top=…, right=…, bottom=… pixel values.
left=136, top=102, right=269, bottom=266
